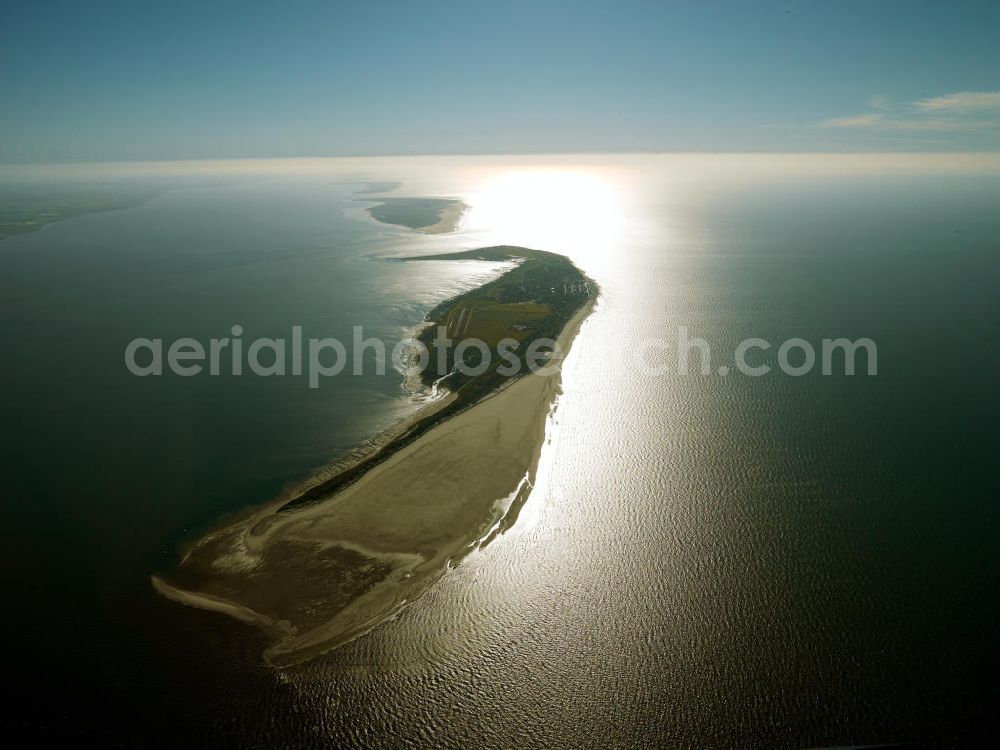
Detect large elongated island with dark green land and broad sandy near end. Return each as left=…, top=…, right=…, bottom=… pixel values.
left=152, top=246, right=598, bottom=667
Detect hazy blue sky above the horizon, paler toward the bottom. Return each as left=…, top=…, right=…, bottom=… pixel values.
left=0, top=0, right=1000, bottom=162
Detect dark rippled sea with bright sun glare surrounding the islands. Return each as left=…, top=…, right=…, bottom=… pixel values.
left=0, top=157, right=1000, bottom=748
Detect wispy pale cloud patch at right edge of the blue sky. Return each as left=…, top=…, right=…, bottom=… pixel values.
left=823, top=91, right=1000, bottom=133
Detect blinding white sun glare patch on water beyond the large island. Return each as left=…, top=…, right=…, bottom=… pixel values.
left=463, top=168, right=625, bottom=274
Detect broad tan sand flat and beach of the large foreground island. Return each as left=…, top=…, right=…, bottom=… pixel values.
left=153, top=300, right=594, bottom=666
